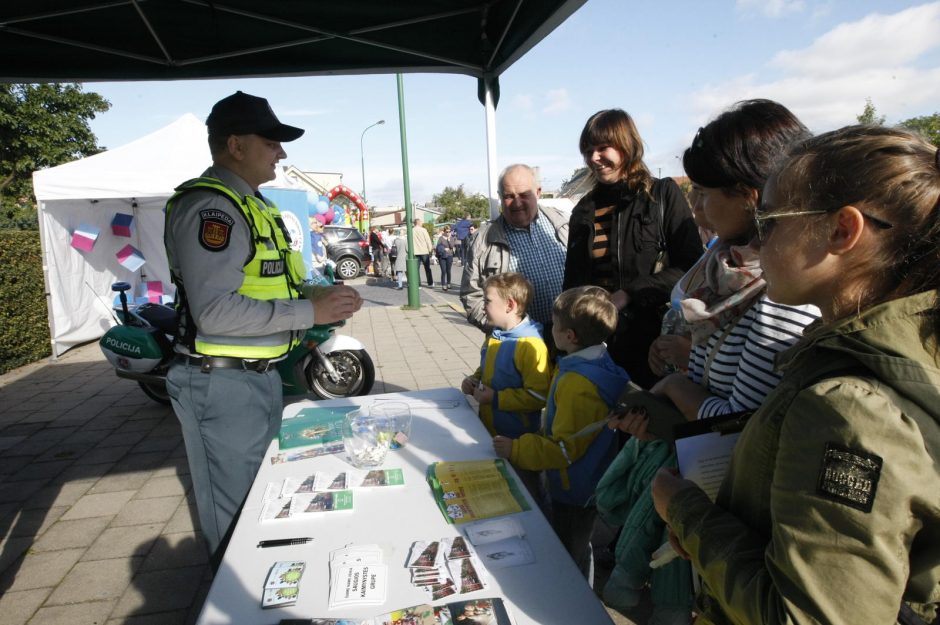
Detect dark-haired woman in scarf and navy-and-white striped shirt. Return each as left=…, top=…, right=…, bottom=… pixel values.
left=599, top=100, right=818, bottom=623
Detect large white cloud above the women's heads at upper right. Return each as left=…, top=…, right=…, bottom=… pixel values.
left=690, top=2, right=940, bottom=132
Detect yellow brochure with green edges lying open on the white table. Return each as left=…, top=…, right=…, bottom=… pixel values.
left=427, top=458, right=529, bottom=524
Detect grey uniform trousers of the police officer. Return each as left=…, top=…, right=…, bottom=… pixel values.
left=167, top=362, right=283, bottom=553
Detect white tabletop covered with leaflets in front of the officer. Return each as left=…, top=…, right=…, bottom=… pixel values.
left=198, top=388, right=611, bottom=625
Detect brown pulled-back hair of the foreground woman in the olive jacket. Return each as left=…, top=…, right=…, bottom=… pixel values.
left=775, top=126, right=940, bottom=326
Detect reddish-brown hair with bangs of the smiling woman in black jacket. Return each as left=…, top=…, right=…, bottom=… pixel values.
left=578, top=109, right=653, bottom=195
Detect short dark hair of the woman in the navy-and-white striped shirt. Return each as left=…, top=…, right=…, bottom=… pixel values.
left=682, top=100, right=810, bottom=195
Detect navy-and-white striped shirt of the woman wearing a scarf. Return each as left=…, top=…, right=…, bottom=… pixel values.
left=689, top=295, right=819, bottom=419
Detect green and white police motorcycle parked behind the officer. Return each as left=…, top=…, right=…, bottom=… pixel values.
left=98, top=266, right=375, bottom=405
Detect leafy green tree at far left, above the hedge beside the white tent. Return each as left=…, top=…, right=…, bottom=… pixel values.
left=0, top=83, right=111, bottom=228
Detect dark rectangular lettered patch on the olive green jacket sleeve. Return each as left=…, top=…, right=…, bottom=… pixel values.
left=816, top=443, right=883, bottom=512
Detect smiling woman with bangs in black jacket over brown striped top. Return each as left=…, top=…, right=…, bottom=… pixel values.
left=563, top=109, right=703, bottom=388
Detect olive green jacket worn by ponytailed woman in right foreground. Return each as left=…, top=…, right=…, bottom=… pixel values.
left=667, top=291, right=940, bottom=625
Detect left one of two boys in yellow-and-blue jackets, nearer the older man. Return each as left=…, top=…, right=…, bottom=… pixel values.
left=460, top=272, right=552, bottom=504
